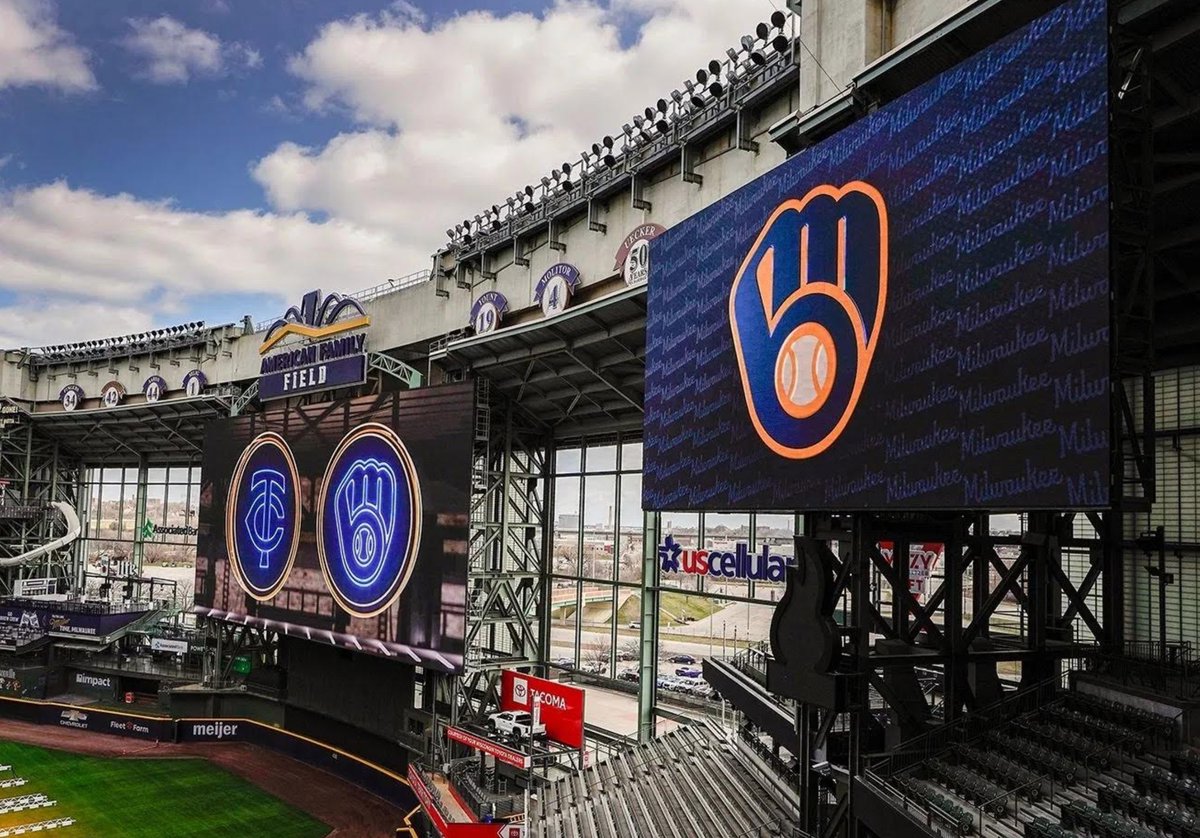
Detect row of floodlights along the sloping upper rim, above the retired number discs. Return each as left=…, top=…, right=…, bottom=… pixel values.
left=446, top=11, right=794, bottom=251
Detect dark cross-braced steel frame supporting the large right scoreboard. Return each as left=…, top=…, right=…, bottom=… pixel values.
left=797, top=16, right=1156, bottom=838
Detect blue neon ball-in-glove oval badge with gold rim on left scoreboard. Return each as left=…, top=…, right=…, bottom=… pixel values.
left=317, top=423, right=421, bottom=617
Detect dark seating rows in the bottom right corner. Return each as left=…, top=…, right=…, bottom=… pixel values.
left=876, top=692, right=1200, bottom=838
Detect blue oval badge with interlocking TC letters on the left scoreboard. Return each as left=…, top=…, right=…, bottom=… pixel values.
left=226, top=431, right=300, bottom=601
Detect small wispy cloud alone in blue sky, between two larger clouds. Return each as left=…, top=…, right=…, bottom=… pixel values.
left=121, top=14, right=263, bottom=84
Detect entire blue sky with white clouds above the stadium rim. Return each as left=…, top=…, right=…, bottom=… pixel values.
left=0, top=0, right=775, bottom=346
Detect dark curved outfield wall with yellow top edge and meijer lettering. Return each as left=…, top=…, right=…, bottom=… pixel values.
left=0, top=696, right=419, bottom=826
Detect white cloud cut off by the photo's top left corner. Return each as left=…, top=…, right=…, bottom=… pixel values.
left=0, top=0, right=96, bottom=92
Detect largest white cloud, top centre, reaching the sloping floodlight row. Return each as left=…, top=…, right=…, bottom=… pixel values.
left=253, top=0, right=770, bottom=237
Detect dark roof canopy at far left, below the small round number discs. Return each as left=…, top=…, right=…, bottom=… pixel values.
left=25, top=394, right=230, bottom=466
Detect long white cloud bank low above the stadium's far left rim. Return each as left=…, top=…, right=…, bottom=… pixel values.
left=0, top=182, right=417, bottom=346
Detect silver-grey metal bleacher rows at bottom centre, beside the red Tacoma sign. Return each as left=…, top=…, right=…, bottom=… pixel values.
left=538, top=723, right=796, bottom=838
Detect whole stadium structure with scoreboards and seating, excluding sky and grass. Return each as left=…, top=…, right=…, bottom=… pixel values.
left=0, top=0, right=1200, bottom=838
